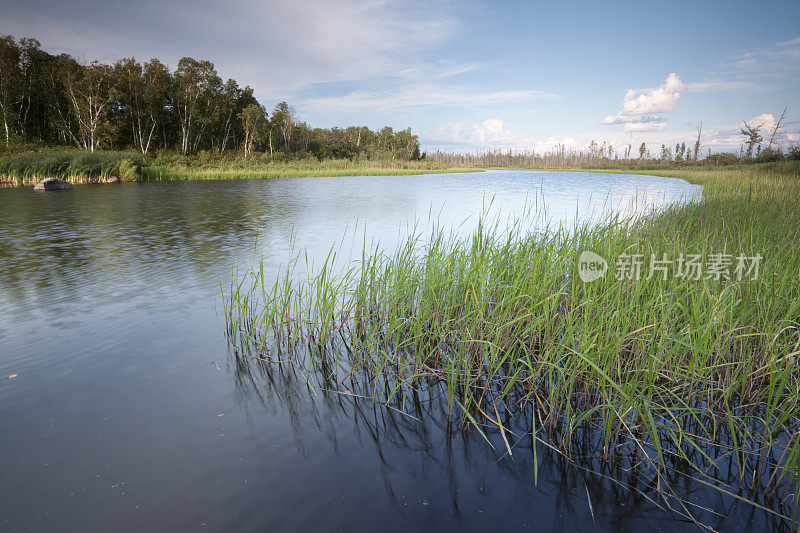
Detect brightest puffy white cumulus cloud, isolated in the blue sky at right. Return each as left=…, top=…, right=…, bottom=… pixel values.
left=602, top=72, right=687, bottom=132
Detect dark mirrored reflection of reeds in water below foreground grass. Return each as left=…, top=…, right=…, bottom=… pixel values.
left=225, top=343, right=792, bottom=532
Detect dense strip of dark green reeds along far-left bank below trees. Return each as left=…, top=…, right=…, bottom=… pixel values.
left=0, top=151, right=142, bottom=181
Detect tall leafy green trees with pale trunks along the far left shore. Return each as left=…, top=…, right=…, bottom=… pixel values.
left=0, top=35, right=420, bottom=160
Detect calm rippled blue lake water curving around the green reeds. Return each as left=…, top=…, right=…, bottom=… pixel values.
left=0, top=171, right=780, bottom=531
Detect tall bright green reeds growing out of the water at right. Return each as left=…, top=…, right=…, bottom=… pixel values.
left=226, top=165, right=800, bottom=520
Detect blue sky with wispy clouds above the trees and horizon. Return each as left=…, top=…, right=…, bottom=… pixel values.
left=0, top=0, right=800, bottom=151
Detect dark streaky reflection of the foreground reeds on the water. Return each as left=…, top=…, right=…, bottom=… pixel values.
left=231, top=342, right=791, bottom=531
